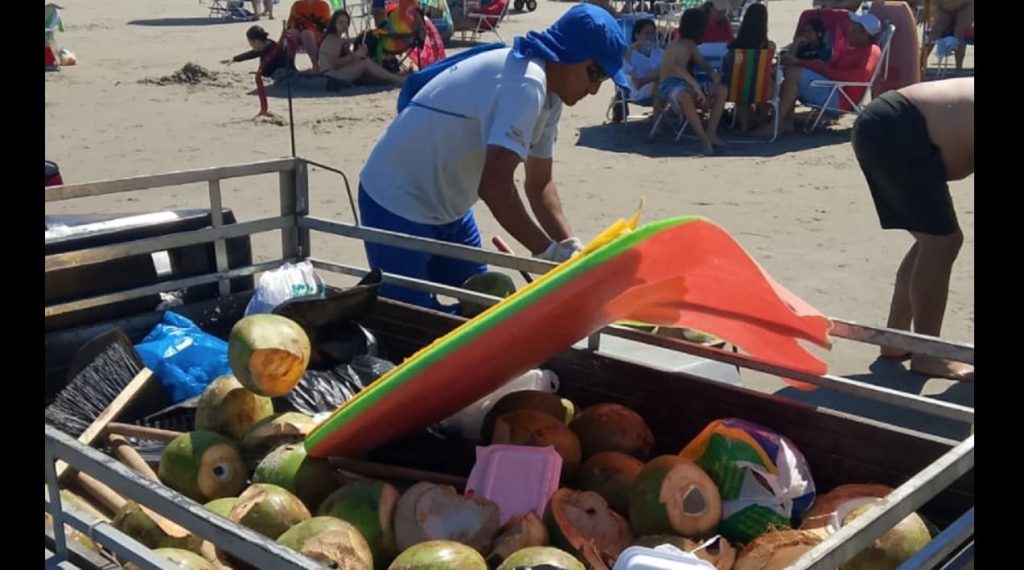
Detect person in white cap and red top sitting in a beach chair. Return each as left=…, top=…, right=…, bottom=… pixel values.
left=765, top=12, right=882, bottom=134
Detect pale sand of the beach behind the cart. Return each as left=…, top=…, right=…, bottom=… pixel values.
left=45, top=0, right=975, bottom=431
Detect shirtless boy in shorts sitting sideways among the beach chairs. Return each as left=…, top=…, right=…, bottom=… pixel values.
left=657, top=8, right=729, bottom=155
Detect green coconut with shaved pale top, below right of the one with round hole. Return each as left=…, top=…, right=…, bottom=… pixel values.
left=227, top=483, right=311, bottom=540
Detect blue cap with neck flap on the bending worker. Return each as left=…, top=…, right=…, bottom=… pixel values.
left=513, top=4, right=630, bottom=90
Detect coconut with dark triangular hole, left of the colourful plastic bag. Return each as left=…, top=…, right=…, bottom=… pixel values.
left=629, top=455, right=722, bottom=537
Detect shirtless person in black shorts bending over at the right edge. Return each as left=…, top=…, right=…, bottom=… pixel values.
left=853, top=78, right=974, bottom=382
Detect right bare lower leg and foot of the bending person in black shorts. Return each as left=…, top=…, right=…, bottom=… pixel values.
left=910, top=230, right=974, bottom=382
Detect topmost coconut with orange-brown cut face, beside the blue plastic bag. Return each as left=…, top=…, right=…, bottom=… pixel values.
left=227, top=313, right=310, bottom=398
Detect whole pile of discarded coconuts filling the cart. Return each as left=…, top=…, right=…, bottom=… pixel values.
left=56, top=315, right=930, bottom=570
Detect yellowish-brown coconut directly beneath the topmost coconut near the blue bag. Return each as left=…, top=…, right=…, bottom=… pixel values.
left=196, top=375, right=273, bottom=441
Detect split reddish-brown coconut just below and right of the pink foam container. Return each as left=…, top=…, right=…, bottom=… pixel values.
left=544, top=489, right=633, bottom=570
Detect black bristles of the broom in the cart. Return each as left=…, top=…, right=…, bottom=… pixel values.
left=44, top=342, right=142, bottom=438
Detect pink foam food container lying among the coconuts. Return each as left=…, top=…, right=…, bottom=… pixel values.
left=466, top=444, right=562, bottom=524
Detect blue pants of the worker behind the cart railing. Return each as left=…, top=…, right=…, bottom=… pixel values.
left=359, top=183, right=487, bottom=313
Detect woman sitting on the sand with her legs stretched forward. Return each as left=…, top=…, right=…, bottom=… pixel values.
left=318, top=10, right=406, bottom=86
